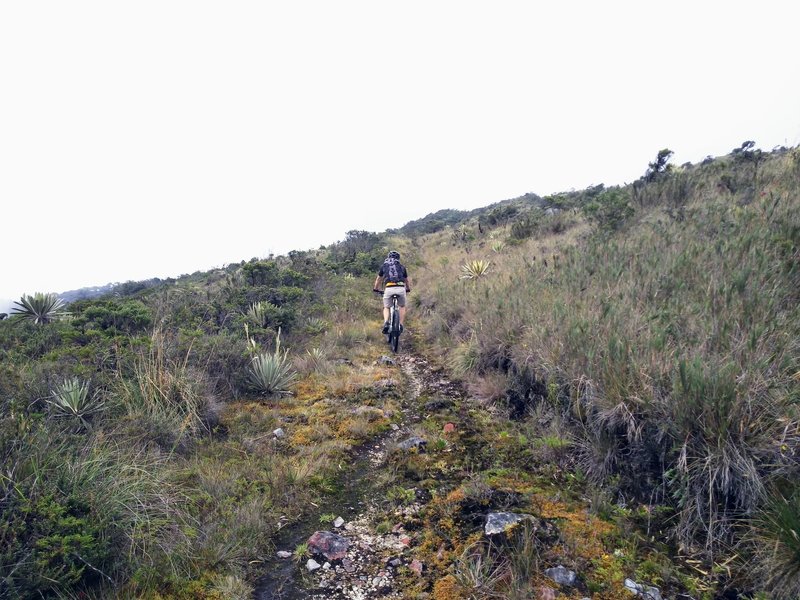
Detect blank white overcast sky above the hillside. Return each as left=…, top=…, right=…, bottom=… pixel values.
left=0, top=0, right=800, bottom=299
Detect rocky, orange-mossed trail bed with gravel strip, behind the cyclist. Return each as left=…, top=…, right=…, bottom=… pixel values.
left=254, top=338, right=668, bottom=600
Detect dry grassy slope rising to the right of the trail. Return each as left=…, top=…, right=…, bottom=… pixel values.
left=407, top=144, right=800, bottom=598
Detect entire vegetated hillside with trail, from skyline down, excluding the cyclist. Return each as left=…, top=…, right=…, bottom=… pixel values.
left=0, top=144, right=800, bottom=600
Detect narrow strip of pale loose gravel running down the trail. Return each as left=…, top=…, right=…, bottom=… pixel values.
left=254, top=336, right=460, bottom=600
